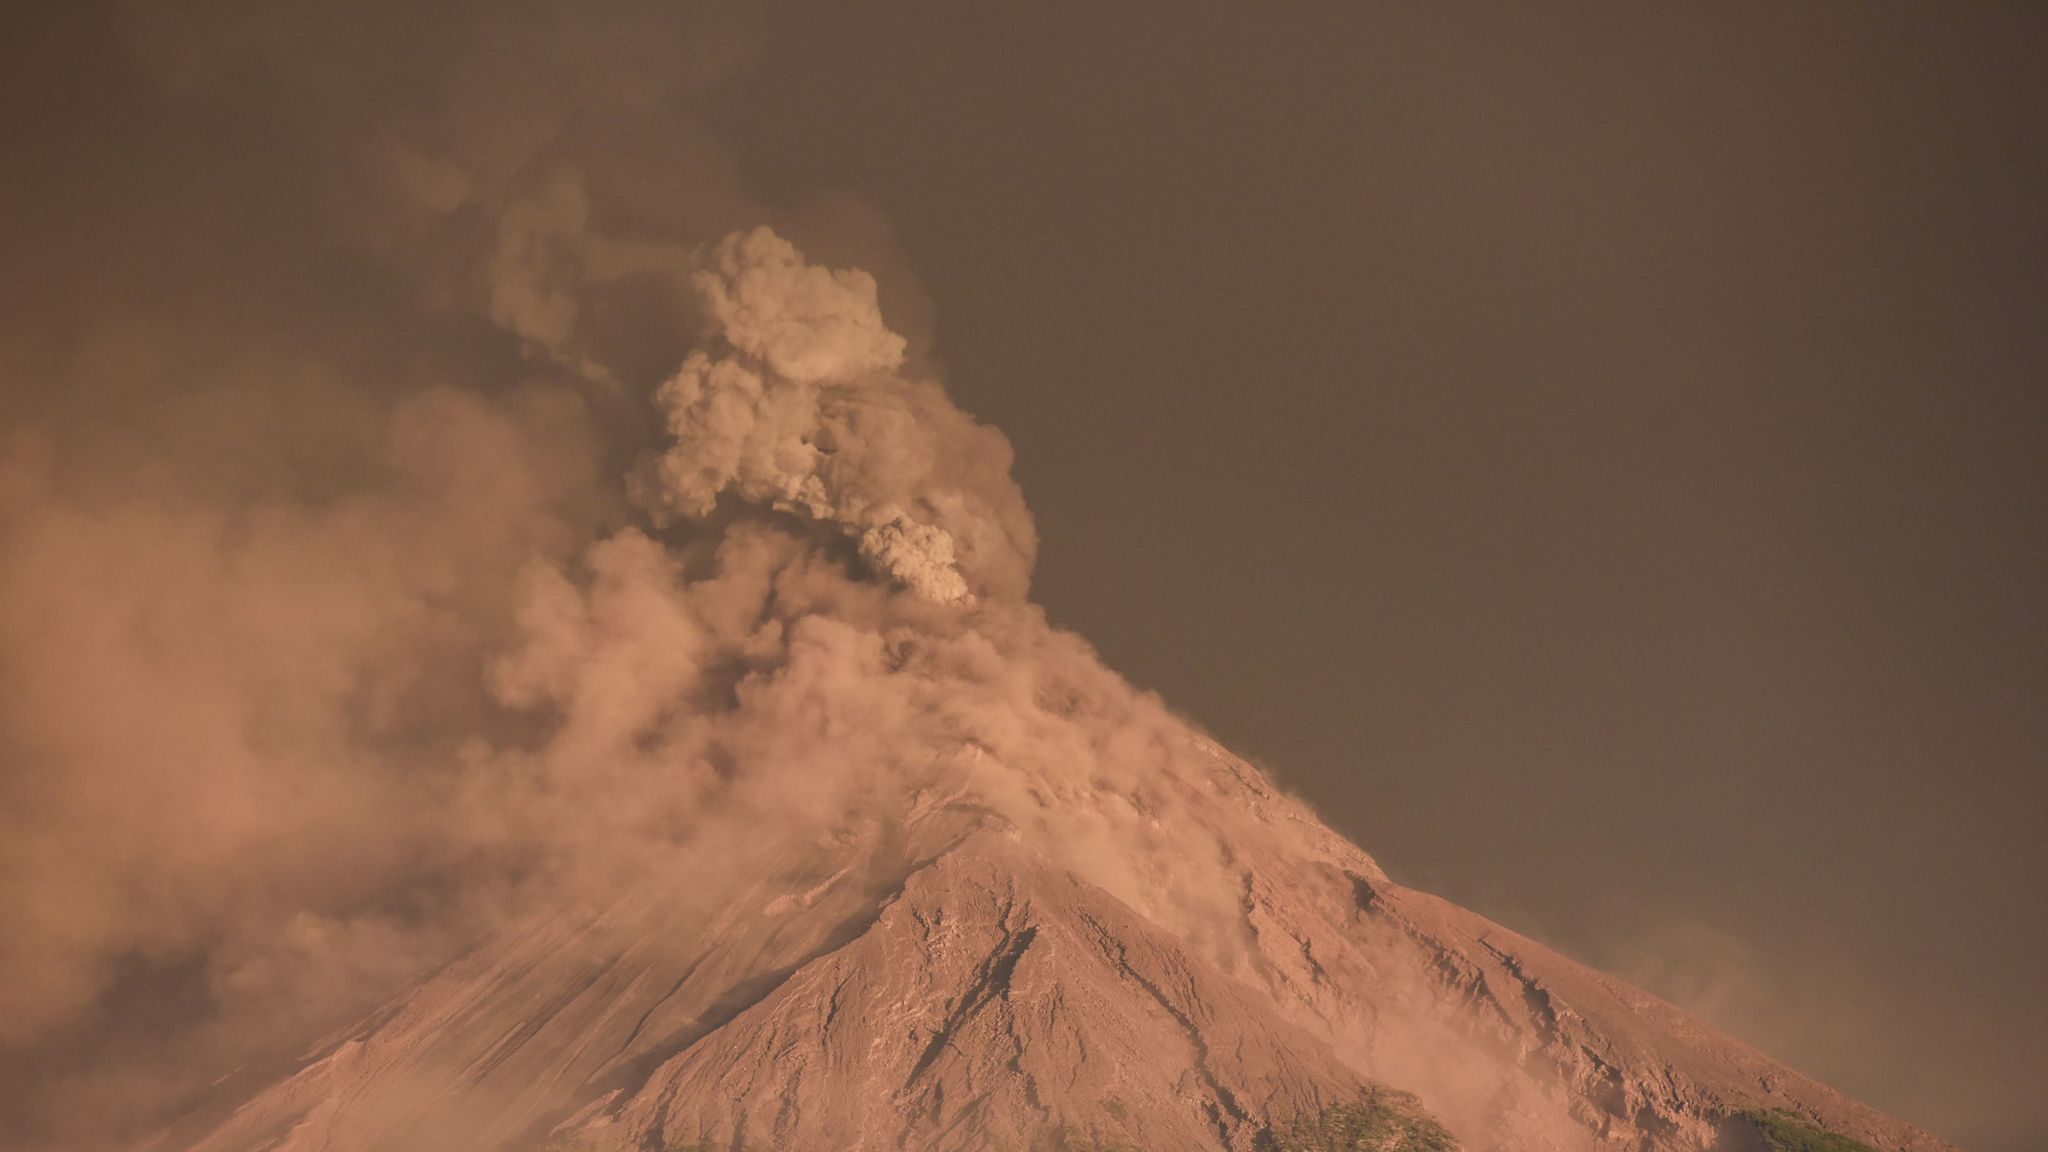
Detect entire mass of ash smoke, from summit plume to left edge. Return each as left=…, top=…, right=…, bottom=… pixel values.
left=0, top=6, right=1231, bottom=1150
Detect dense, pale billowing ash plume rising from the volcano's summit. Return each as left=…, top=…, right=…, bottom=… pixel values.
left=647, top=230, right=1034, bottom=603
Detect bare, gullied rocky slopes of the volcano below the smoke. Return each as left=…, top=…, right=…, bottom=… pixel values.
left=158, top=746, right=1948, bottom=1152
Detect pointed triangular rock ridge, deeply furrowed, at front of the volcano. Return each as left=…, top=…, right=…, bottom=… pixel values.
left=563, top=838, right=1366, bottom=1152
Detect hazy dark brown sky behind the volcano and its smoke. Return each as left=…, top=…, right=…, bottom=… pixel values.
left=0, top=4, right=2048, bottom=1152
